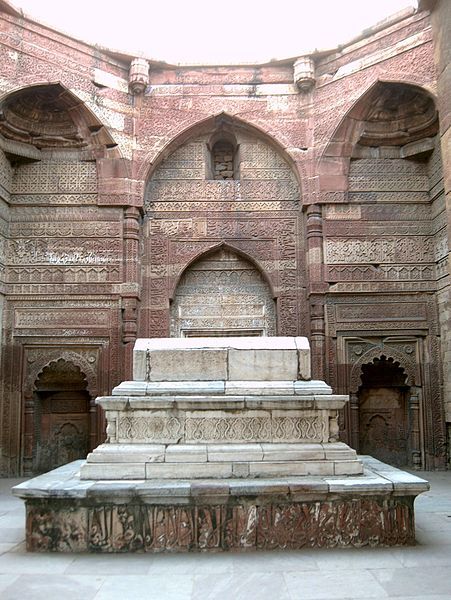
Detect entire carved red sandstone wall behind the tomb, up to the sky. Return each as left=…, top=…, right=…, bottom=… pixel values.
left=0, top=5, right=451, bottom=474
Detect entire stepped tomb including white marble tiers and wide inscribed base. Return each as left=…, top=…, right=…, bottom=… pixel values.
left=14, top=337, right=428, bottom=552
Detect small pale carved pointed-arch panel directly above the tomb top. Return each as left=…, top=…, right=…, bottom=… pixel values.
left=170, top=247, right=276, bottom=337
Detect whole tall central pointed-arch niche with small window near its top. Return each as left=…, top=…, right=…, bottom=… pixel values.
left=144, top=114, right=310, bottom=337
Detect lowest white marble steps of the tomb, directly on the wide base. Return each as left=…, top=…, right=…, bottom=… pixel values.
left=80, top=443, right=363, bottom=480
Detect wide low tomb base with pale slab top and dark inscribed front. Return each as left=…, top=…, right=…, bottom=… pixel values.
left=13, top=457, right=429, bottom=553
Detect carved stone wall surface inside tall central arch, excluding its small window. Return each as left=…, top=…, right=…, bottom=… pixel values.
left=144, top=129, right=309, bottom=337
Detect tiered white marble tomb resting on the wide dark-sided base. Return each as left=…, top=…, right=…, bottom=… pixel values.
left=80, top=337, right=363, bottom=480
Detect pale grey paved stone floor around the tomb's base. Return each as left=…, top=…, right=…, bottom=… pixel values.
left=0, top=472, right=451, bottom=600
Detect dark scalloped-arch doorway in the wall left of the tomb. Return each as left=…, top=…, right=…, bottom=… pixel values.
left=33, top=359, right=91, bottom=473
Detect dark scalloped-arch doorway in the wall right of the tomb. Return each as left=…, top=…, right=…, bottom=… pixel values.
left=358, top=355, right=414, bottom=466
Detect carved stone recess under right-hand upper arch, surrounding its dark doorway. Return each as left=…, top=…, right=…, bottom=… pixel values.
left=323, top=78, right=448, bottom=467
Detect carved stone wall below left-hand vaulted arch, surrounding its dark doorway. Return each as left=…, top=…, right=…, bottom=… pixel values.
left=1, top=151, right=123, bottom=474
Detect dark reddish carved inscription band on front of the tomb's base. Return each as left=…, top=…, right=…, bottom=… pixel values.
left=28, top=498, right=414, bottom=552
